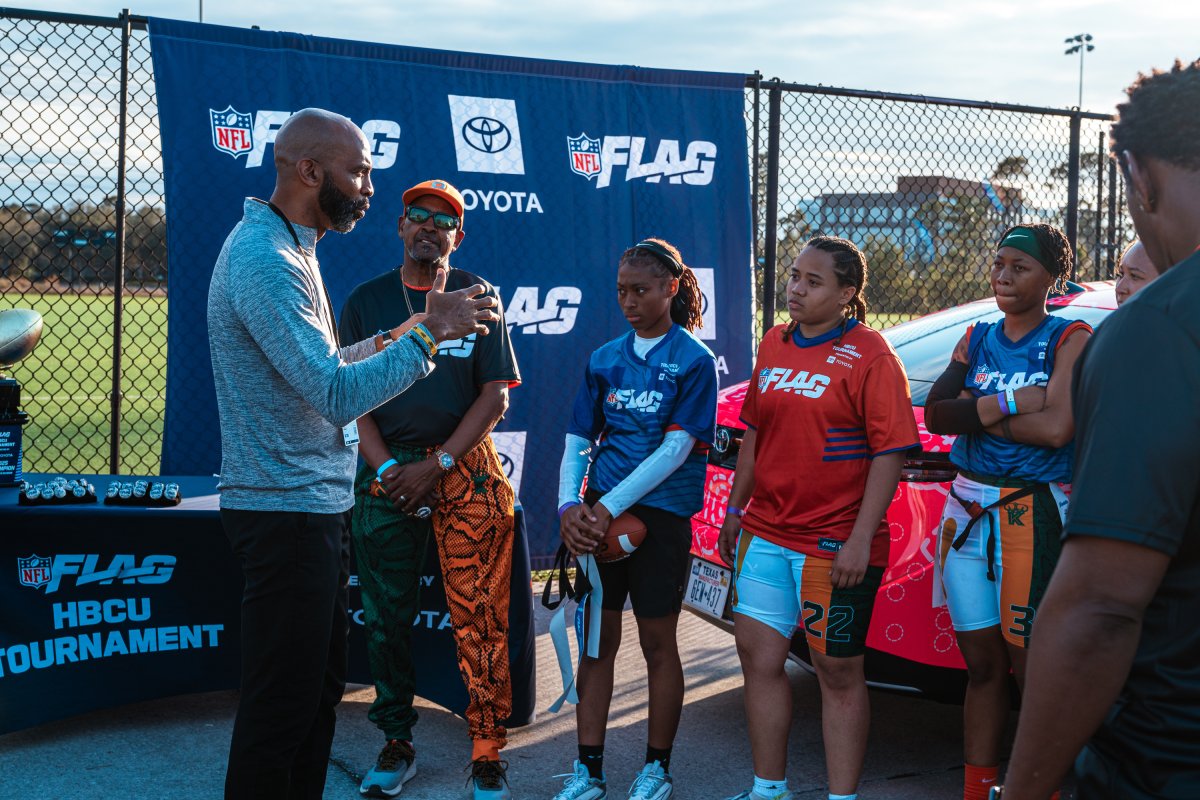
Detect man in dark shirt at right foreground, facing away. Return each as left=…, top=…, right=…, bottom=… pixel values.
left=995, top=61, right=1200, bottom=800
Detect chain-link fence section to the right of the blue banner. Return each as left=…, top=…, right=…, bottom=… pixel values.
left=748, top=78, right=1130, bottom=327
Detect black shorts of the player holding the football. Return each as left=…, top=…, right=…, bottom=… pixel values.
left=583, top=489, right=691, bottom=619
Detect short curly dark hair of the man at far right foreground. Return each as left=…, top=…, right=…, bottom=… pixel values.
left=1110, top=59, right=1200, bottom=172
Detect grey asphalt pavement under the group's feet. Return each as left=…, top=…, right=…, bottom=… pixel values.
left=0, top=585, right=993, bottom=800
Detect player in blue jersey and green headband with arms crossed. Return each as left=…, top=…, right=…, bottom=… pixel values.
left=925, top=224, right=1092, bottom=800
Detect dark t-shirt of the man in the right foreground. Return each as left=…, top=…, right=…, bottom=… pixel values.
left=1063, top=253, right=1200, bottom=800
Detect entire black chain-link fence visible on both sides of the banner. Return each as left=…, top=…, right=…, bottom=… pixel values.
left=0, top=10, right=1132, bottom=474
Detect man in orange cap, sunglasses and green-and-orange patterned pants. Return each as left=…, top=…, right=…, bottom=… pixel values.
left=341, top=180, right=521, bottom=800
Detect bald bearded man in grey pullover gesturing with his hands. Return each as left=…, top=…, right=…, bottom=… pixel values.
left=208, top=108, right=498, bottom=800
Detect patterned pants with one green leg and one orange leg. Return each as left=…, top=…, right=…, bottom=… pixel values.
left=350, top=438, right=514, bottom=750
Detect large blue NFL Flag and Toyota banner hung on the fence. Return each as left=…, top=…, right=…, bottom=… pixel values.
left=150, top=19, right=754, bottom=558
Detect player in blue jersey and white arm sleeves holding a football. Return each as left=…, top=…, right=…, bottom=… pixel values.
left=554, top=239, right=716, bottom=800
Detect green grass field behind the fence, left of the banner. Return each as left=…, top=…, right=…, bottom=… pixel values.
left=0, top=294, right=167, bottom=475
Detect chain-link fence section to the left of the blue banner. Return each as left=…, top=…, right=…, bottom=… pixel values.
left=0, top=12, right=167, bottom=474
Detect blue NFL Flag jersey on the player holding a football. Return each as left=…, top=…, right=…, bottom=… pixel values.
left=568, top=325, right=716, bottom=517
